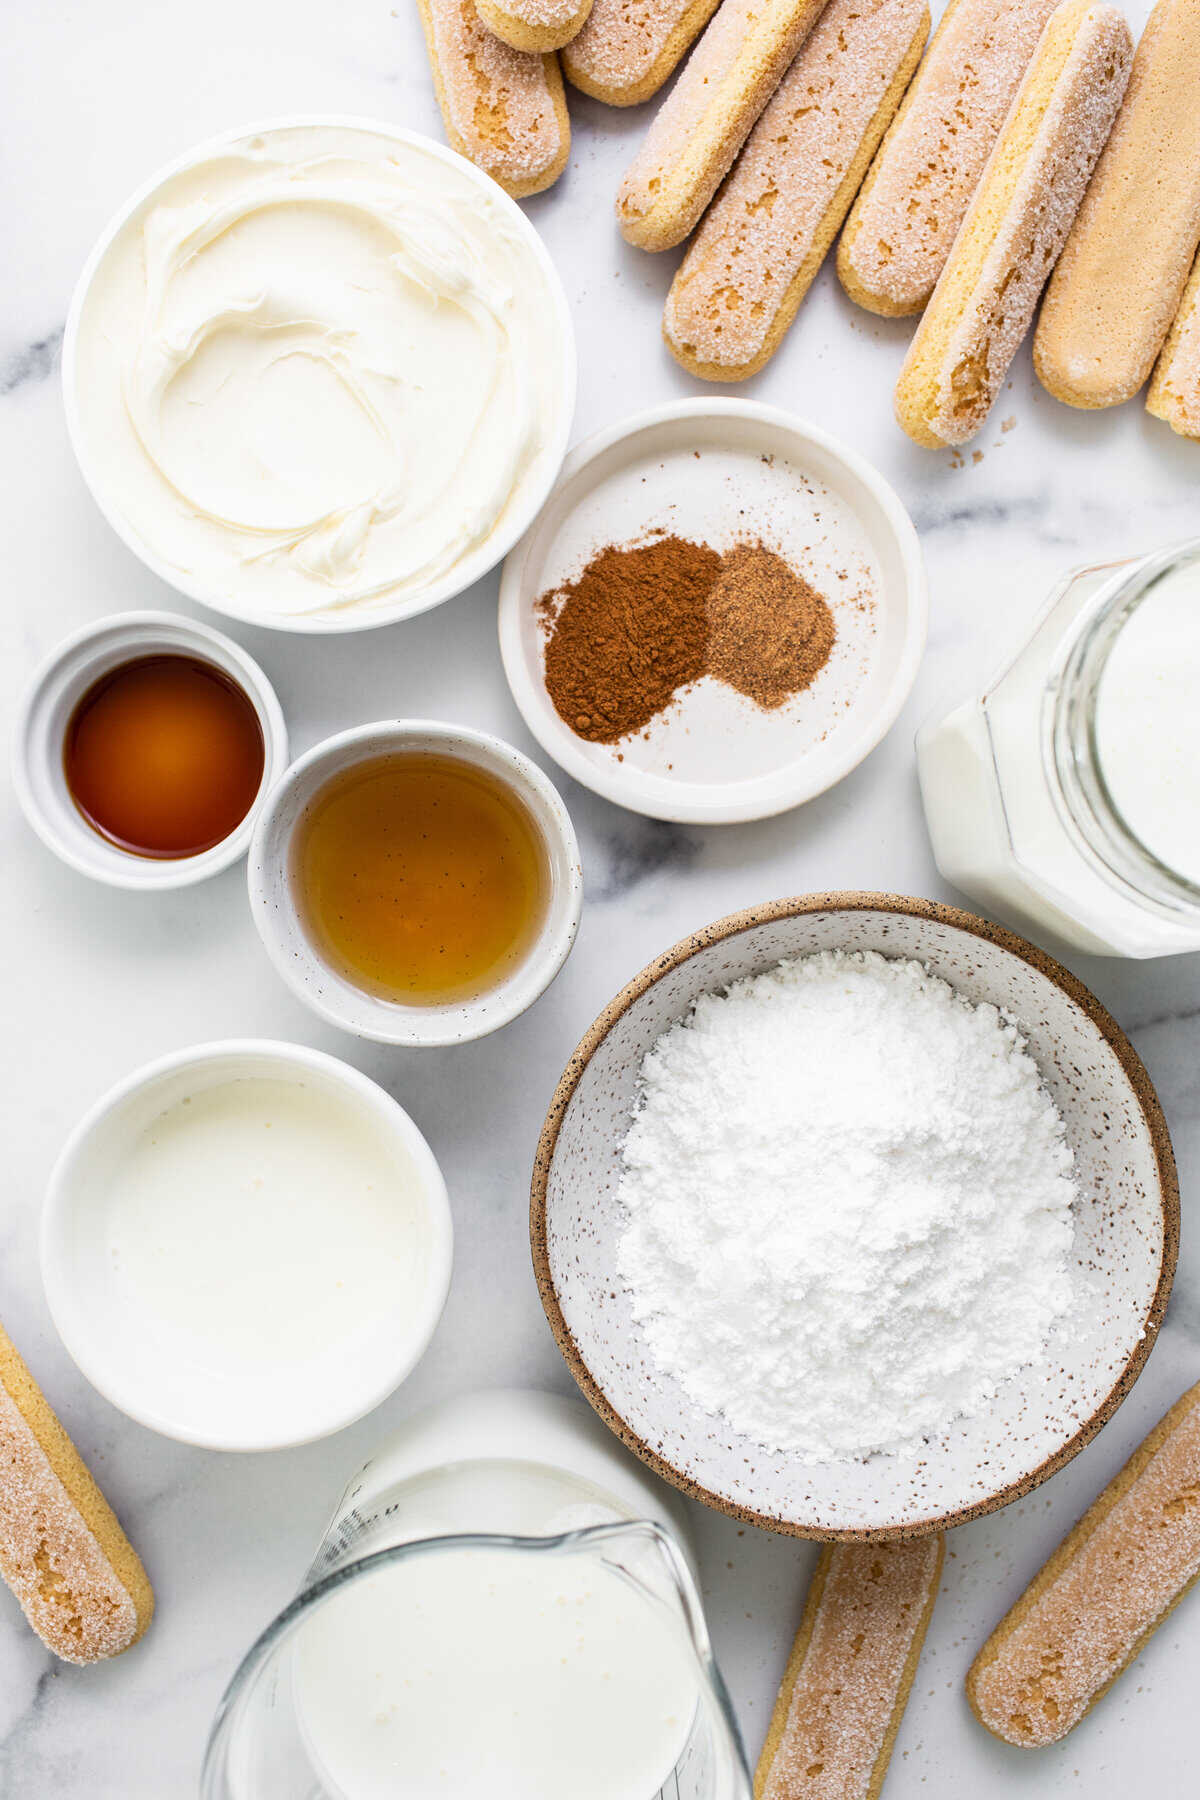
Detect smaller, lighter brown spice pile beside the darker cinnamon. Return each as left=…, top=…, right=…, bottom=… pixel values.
left=707, top=544, right=835, bottom=709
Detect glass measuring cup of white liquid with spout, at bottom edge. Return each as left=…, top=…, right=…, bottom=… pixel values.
left=201, top=1393, right=750, bottom=1800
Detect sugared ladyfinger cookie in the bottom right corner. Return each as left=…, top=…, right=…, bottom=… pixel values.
left=966, top=1384, right=1200, bottom=1746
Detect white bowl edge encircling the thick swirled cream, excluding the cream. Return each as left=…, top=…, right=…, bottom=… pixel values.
left=63, top=113, right=576, bottom=635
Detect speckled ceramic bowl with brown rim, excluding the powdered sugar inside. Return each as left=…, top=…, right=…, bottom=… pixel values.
left=531, top=893, right=1178, bottom=1539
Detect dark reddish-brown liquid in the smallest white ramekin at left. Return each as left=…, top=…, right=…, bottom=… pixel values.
left=63, top=655, right=266, bottom=859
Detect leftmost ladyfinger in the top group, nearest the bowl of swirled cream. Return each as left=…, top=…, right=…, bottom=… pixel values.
left=417, top=0, right=570, bottom=200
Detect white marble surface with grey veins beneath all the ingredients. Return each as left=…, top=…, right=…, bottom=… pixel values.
left=0, top=0, right=1200, bottom=1800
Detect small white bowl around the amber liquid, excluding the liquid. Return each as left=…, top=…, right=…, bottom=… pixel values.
left=248, top=718, right=583, bottom=1046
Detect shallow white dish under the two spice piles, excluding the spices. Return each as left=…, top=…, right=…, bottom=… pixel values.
left=500, top=400, right=928, bottom=824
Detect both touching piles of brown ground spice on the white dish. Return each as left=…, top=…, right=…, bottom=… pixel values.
left=536, top=536, right=835, bottom=743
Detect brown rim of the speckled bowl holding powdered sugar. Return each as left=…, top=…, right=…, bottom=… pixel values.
left=529, top=889, right=1180, bottom=1543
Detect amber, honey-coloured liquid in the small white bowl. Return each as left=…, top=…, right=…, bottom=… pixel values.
left=293, top=752, right=549, bottom=1006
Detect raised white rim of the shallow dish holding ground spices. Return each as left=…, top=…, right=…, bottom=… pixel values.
left=497, top=394, right=928, bottom=824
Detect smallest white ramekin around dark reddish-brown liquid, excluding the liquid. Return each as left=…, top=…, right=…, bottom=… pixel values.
left=13, top=612, right=288, bottom=889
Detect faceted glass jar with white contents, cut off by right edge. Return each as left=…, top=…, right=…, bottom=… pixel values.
left=918, top=538, right=1200, bottom=956
